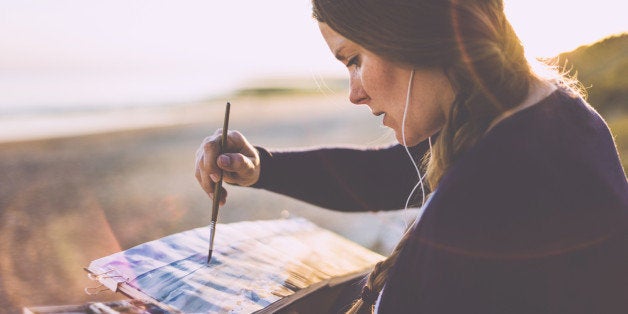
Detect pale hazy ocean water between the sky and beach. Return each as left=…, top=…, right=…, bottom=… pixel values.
left=0, top=70, right=237, bottom=142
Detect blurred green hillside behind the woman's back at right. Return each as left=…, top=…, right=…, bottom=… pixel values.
left=557, top=33, right=628, bottom=172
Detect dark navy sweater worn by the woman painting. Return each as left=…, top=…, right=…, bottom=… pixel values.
left=256, top=90, right=628, bottom=314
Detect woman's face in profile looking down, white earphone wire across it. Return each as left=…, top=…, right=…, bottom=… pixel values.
left=319, top=23, right=454, bottom=146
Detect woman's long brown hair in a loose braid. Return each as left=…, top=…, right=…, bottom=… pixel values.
left=312, top=0, right=534, bottom=313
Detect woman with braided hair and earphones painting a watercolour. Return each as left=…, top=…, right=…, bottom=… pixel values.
left=196, top=0, right=628, bottom=313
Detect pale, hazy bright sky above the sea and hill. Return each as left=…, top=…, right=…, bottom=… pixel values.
left=0, top=0, right=628, bottom=111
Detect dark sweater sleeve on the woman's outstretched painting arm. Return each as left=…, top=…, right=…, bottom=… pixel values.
left=253, top=142, right=429, bottom=211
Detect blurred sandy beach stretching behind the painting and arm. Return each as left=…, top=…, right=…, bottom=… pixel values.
left=0, top=93, right=412, bottom=312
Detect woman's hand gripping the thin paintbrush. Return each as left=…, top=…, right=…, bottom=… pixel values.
left=195, top=129, right=260, bottom=205
